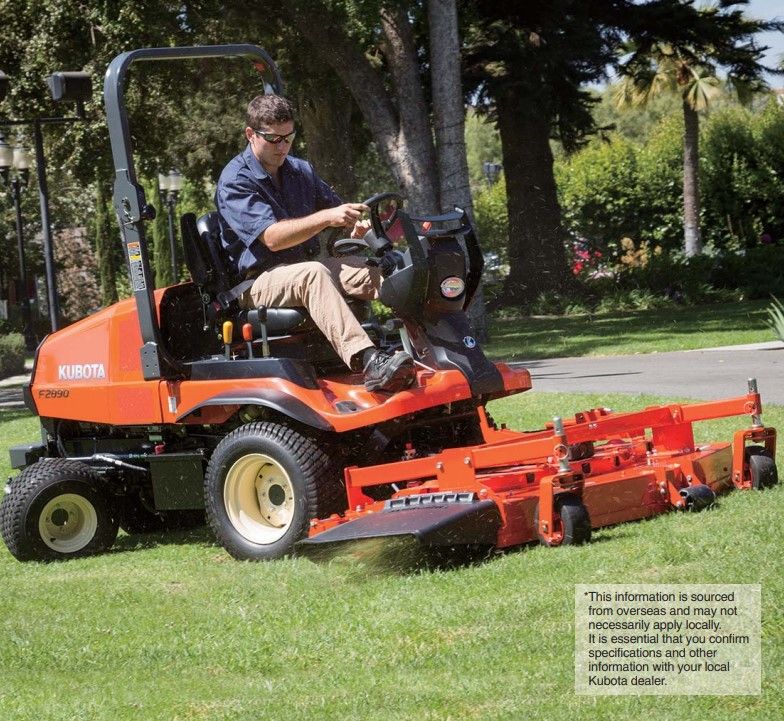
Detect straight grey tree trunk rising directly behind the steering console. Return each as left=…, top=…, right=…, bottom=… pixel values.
left=427, top=0, right=488, bottom=341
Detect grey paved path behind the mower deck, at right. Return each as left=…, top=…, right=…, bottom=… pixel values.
left=514, top=343, right=784, bottom=405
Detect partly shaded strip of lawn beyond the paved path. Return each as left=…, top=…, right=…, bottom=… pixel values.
left=486, top=301, right=776, bottom=359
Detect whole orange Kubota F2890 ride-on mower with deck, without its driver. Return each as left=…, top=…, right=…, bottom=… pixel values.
left=0, top=45, right=778, bottom=561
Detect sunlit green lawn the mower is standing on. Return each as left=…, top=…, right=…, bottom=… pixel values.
left=0, top=392, right=784, bottom=721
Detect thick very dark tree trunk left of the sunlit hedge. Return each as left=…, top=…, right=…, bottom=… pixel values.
left=496, top=93, right=575, bottom=305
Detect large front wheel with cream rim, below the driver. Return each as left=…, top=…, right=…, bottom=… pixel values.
left=204, top=422, right=338, bottom=561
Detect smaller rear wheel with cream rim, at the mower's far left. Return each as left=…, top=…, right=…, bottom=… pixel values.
left=0, top=458, right=118, bottom=561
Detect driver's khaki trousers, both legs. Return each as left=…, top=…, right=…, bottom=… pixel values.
left=242, top=256, right=381, bottom=367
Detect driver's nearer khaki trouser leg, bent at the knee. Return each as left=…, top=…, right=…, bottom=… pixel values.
left=250, top=261, right=373, bottom=368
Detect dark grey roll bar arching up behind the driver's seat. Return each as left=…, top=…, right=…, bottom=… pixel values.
left=103, top=44, right=283, bottom=380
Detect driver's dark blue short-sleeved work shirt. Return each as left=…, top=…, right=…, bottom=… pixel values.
left=215, top=145, right=343, bottom=278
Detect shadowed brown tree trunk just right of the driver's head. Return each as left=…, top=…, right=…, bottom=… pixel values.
left=297, top=75, right=359, bottom=202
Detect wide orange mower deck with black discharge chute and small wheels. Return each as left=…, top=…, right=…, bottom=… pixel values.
left=299, top=380, right=778, bottom=550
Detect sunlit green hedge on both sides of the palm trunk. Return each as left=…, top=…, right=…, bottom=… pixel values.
left=556, top=102, right=784, bottom=256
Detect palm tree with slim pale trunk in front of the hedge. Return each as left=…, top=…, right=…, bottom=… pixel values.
left=615, top=0, right=782, bottom=256
